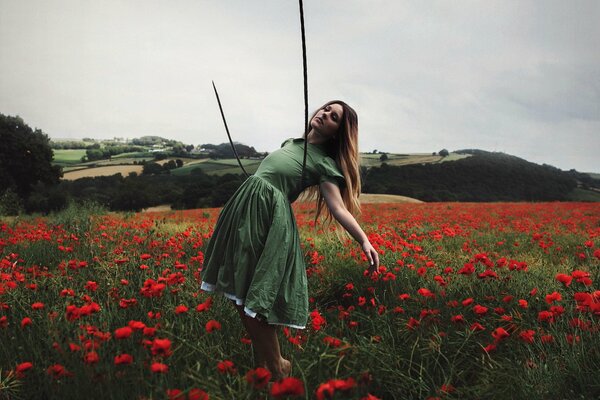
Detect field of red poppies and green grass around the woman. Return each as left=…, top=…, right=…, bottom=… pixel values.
left=0, top=203, right=600, bottom=400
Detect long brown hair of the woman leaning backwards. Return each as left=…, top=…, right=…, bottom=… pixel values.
left=302, top=100, right=361, bottom=241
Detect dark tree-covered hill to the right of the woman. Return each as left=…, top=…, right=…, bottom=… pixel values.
left=363, top=150, right=589, bottom=202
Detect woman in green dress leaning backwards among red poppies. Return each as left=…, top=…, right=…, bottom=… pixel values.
left=201, top=100, right=379, bottom=380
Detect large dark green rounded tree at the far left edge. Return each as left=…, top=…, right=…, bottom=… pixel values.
left=0, top=114, right=62, bottom=198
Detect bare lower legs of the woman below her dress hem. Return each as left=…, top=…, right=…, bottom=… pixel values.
left=236, top=305, right=291, bottom=381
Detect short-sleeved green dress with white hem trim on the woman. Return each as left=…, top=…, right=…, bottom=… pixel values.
left=201, top=138, right=345, bottom=329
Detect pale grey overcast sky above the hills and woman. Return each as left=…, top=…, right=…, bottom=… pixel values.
left=0, top=0, right=600, bottom=172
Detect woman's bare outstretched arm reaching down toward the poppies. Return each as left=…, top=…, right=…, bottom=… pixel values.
left=320, top=182, right=379, bottom=268
